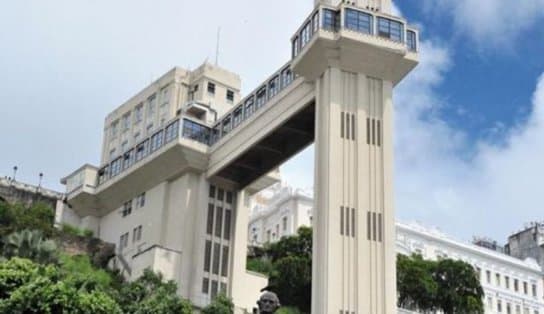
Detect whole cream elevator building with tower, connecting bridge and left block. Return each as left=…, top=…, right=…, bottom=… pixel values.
left=58, top=0, right=418, bottom=314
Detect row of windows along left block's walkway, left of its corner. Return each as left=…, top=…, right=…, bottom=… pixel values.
left=97, top=120, right=179, bottom=185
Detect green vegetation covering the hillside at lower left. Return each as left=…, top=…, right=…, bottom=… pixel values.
left=0, top=202, right=233, bottom=314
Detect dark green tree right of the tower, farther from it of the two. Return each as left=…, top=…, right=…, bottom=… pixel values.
left=433, top=259, right=484, bottom=314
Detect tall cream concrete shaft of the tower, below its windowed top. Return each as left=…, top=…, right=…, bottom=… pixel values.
left=312, top=67, right=397, bottom=314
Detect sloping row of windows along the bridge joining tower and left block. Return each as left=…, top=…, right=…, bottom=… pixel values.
left=208, top=67, right=294, bottom=145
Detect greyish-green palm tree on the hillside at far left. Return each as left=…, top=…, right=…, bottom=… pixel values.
left=3, top=230, right=57, bottom=264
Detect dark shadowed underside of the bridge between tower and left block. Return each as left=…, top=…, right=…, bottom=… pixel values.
left=217, top=102, right=315, bottom=188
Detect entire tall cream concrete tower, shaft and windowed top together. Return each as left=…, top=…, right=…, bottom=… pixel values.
left=292, top=0, right=417, bottom=314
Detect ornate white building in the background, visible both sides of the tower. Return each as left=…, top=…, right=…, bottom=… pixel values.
left=248, top=185, right=544, bottom=314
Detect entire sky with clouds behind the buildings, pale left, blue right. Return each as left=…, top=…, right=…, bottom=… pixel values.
left=0, top=0, right=544, bottom=242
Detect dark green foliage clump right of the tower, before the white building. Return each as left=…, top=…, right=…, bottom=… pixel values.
left=397, top=255, right=484, bottom=314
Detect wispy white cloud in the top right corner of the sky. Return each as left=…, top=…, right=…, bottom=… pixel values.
left=425, top=0, right=544, bottom=48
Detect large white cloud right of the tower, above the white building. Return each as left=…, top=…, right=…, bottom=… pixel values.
left=395, top=42, right=544, bottom=241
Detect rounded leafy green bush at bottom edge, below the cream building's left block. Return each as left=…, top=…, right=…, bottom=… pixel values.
left=118, top=269, right=192, bottom=314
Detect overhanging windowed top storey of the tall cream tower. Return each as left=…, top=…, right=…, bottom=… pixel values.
left=291, top=3, right=419, bottom=84
